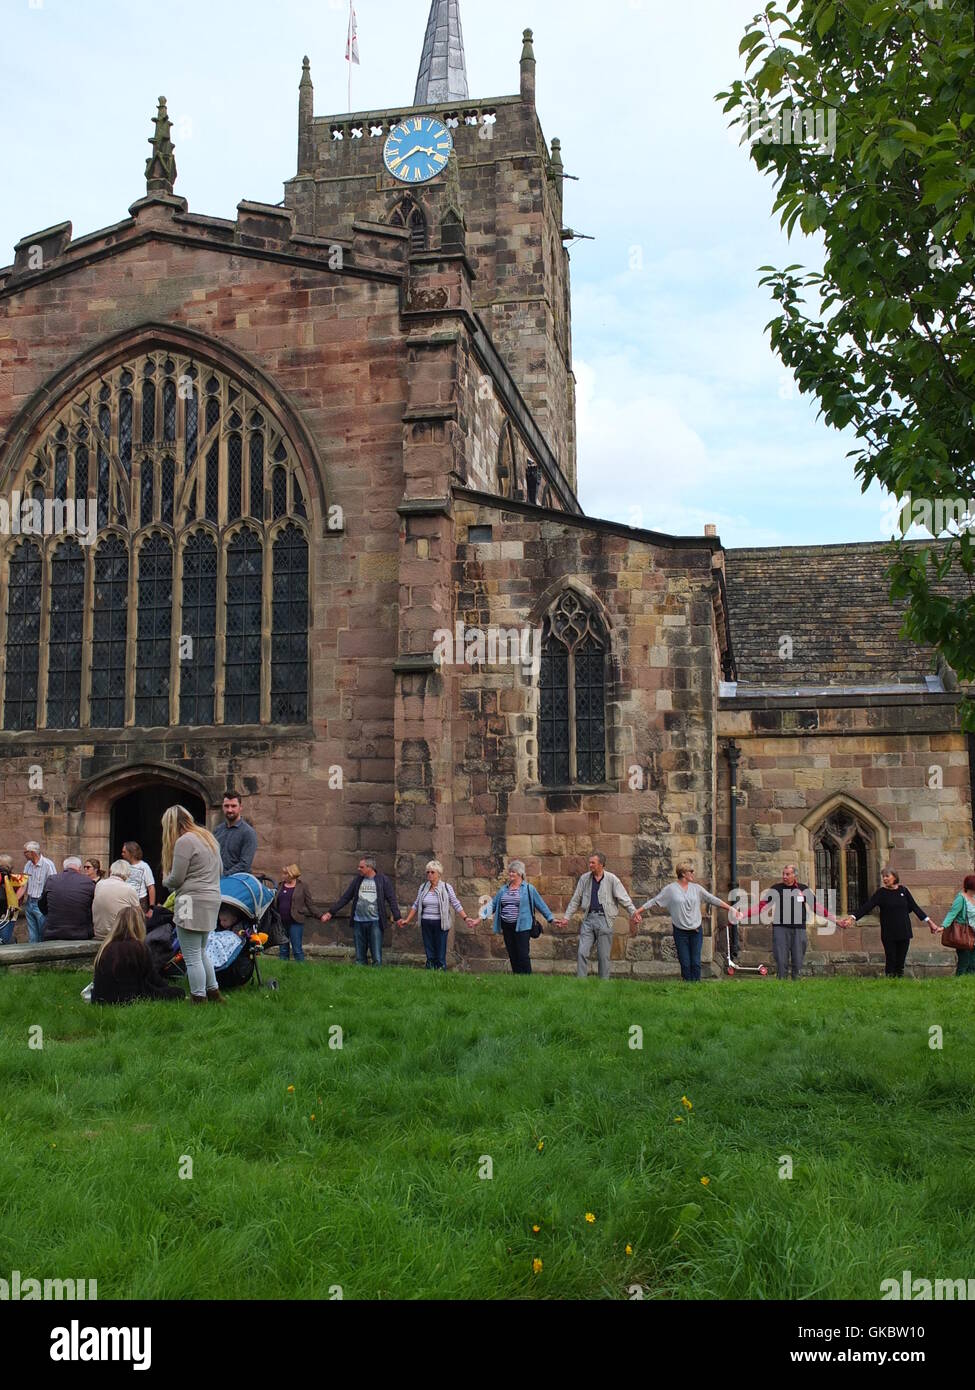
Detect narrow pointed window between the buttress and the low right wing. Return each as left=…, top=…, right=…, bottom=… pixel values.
left=538, top=589, right=609, bottom=787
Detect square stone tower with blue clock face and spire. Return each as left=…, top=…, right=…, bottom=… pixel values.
left=285, top=0, right=576, bottom=491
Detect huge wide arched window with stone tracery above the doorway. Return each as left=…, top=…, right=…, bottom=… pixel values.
left=0, top=348, right=310, bottom=730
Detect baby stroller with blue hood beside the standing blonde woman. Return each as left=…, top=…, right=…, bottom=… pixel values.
left=146, top=873, right=280, bottom=991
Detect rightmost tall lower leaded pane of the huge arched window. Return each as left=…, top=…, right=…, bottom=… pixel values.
left=271, top=525, right=309, bottom=724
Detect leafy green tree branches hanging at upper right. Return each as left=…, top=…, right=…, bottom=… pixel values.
left=718, top=0, right=975, bottom=728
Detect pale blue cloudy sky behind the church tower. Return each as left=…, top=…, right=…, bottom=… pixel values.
left=0, top=0, right=892, bottom=546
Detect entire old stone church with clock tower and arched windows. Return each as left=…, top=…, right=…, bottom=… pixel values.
left=0, top=0, right=972, bottom=977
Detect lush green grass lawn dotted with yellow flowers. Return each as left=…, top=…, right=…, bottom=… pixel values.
left=0, top=960, right=975, bottom=1298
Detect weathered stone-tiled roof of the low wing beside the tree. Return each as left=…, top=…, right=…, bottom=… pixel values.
left=725, top=542, right=968, bottom=695
